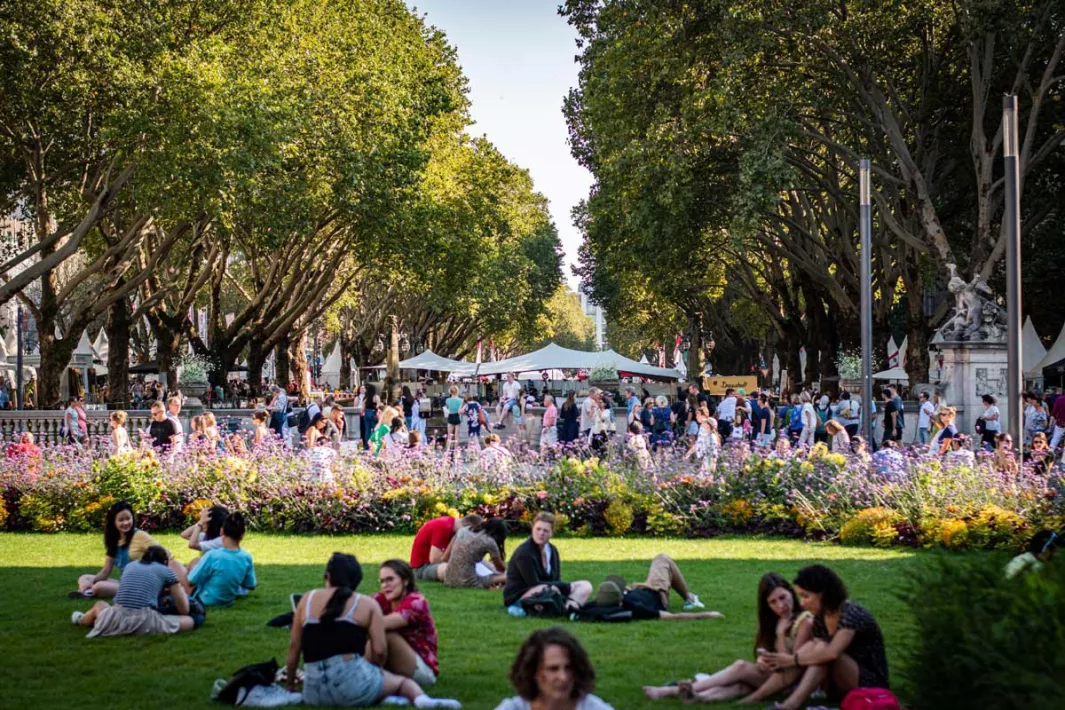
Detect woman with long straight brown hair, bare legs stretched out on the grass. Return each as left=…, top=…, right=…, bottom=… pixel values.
left=643, top=572, right=814, bottom=703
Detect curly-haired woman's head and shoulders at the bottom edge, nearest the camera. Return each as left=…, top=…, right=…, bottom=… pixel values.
left=495, top=626, right=612, bottom=710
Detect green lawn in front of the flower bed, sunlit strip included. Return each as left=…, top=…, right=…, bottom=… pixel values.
left=0, top=533, right=920, bottom=710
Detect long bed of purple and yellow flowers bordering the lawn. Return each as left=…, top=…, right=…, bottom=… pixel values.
left=0, top=445, right=1065, bottom=549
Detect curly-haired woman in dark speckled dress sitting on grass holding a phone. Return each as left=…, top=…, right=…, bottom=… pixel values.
left=763, top=564, right=889, bottom=710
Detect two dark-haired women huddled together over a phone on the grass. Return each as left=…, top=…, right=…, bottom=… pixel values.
left=643, top=564, right=888, bottom=710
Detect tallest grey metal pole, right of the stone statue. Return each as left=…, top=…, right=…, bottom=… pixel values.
left=1002, top=95, right=1025, bottom=451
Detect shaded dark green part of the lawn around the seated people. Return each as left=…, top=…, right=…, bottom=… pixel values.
left=0, top=553, right=920, bottom=710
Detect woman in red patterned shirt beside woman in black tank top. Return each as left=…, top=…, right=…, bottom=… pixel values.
left=374, top=560, right=440, bottom=688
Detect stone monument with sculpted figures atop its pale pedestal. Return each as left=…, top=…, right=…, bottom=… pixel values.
left=935, top=264, right=1014, bottom=435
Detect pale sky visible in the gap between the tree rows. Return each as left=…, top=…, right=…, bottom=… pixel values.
left=408, top=0, right=592, bottom=288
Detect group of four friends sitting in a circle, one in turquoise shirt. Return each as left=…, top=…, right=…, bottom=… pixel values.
left=69, top=500, right=257, bottom=638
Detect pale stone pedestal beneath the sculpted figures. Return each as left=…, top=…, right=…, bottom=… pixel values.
left=939, top=341, right=1012, bottom=435
